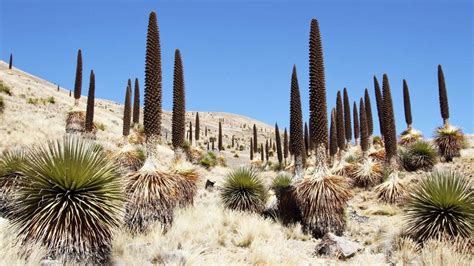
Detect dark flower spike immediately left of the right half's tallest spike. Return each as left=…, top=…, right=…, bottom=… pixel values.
left=290, top=65, right=306, bottom=179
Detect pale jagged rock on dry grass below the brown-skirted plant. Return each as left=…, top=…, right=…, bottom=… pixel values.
left=316, top=233, right=364, bottom=259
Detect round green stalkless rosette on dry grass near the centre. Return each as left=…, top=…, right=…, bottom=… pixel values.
left=220, top=168, right=267, bottom=213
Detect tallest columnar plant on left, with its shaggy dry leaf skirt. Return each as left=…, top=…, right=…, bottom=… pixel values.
left=125, top=12, right=197, bottom=233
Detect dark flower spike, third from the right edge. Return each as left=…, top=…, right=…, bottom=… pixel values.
left=382, top=74, right=397, bottom=164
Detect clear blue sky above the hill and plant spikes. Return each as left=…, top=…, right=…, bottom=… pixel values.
left=0, top=0, right=474, bottom=137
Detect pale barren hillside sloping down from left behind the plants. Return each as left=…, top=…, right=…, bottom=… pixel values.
left=0, top=61, right=274, bottom=151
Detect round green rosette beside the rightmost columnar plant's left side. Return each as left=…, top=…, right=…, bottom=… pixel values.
left=399, top=140, right=437, bottom=171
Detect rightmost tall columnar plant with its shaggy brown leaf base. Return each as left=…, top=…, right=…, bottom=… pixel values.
left=435, top=65, right=464, bottom=162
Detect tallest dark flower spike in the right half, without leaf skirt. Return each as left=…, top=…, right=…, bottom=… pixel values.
left=309, top=19, right=328, bottom=158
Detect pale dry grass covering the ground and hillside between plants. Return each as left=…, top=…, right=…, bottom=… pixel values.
left=0, top=62, right=474, bottom=265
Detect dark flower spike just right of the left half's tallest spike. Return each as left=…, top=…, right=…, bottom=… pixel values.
left=171, top=49, right=186, bottom=151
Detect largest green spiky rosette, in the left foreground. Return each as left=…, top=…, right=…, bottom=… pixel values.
left=11, top=137, right=123, bottom=263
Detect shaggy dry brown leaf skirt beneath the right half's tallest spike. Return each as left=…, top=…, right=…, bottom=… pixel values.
left=294, top=174, right=351, bottom=238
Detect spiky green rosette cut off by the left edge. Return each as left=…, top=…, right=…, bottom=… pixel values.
left=0, top=149, right=25, bottom=218
